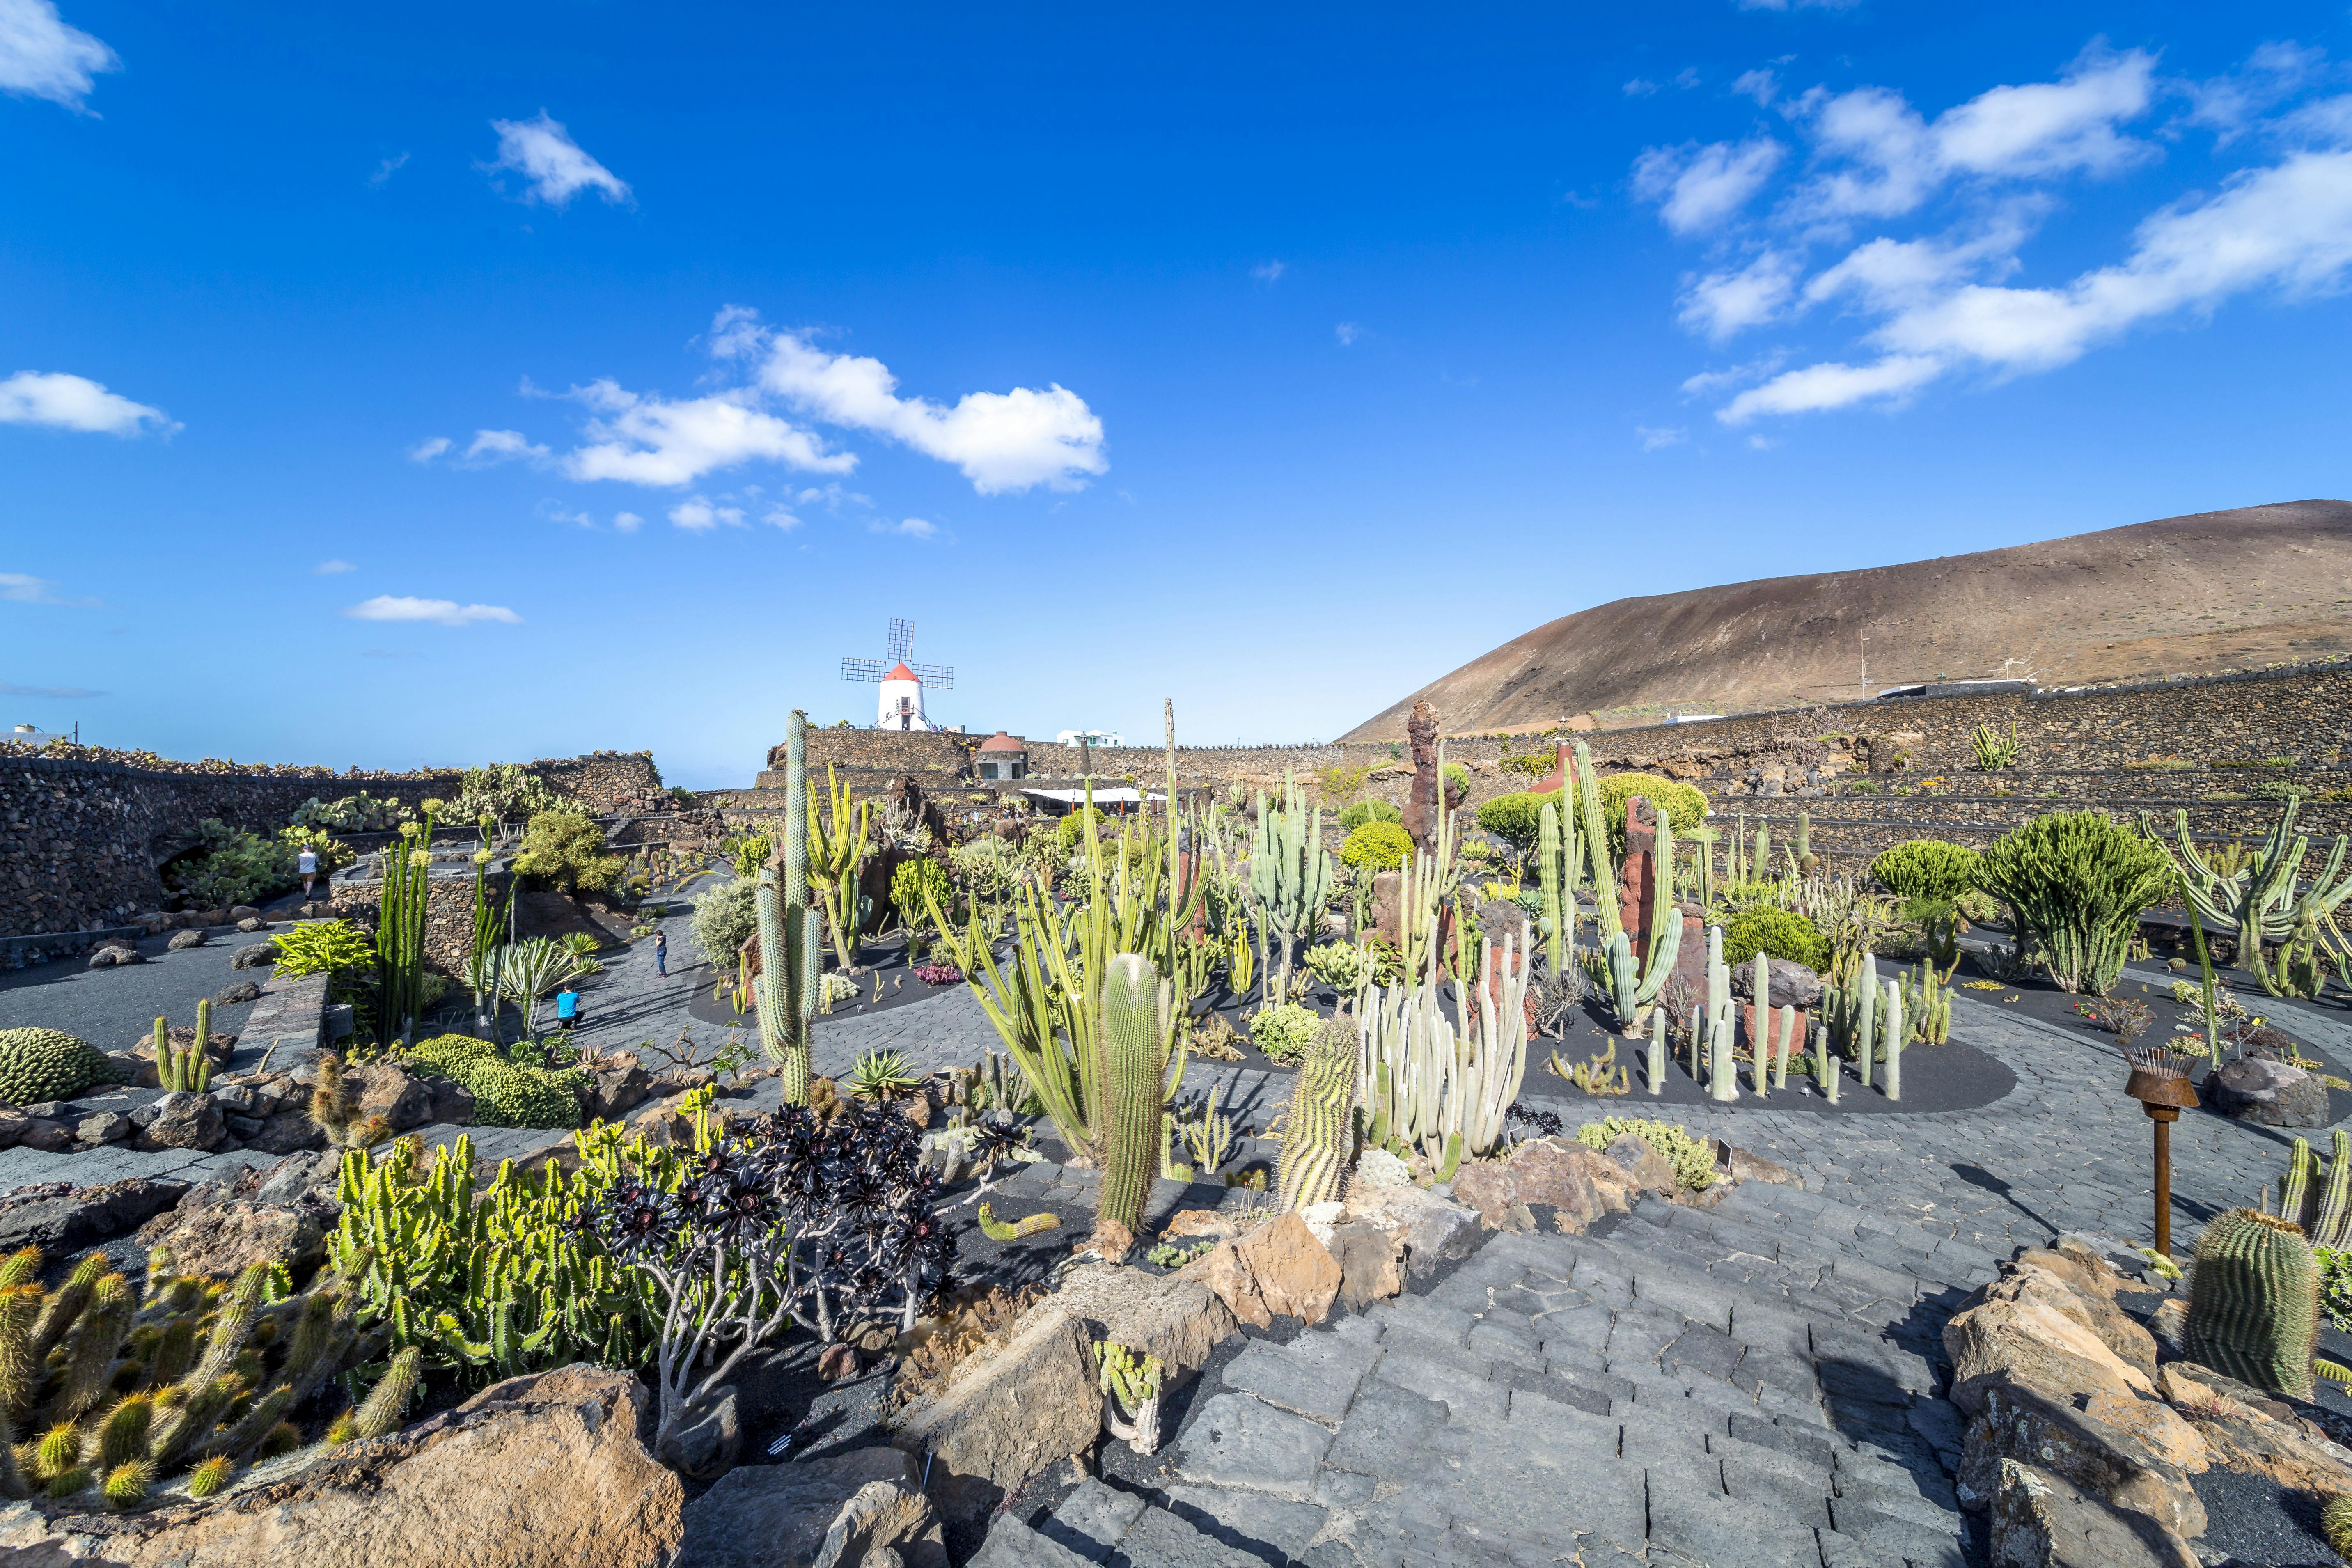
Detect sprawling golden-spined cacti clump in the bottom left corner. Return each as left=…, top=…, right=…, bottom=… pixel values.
left=0, top=1248, right=416, bottom=1509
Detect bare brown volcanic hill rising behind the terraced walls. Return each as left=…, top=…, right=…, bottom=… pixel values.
left=1341, top=501, right=2352, bottom=740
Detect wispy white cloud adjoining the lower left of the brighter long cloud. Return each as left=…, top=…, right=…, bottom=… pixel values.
left=564, top=381, right=858, bottom=487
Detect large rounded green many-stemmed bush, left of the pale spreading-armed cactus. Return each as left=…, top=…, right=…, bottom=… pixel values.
left=1981, top=811, right=2173, bottom=997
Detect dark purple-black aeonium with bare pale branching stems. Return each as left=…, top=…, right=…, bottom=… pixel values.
left=579, top=1103, right=955, bottom=1453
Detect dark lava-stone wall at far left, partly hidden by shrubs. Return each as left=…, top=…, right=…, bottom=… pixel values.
left=0, top=743, right=675, bottom=938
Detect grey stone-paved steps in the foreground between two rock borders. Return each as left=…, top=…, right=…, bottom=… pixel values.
left=1011, top=1190, right=1990, bottom=1568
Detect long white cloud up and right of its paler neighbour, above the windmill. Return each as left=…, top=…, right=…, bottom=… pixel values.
left=743, top=308, right=1110, bottom=496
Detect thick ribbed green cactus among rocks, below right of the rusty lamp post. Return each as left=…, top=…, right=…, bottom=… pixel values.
left=2187, top=1208, right=2319, bottom=1399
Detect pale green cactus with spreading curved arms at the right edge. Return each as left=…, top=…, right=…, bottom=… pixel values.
left=2140, top=797, right=2352, bottom=997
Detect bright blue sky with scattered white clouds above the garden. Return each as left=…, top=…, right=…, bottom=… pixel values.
left=0, top=0, right=2352, bottom=785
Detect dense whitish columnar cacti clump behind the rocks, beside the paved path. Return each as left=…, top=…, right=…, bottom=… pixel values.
left=1357, top=938, right=1529, bottom=1180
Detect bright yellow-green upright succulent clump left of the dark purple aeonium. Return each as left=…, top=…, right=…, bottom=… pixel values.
left=327, top=1128, right=661, bottom=1380
